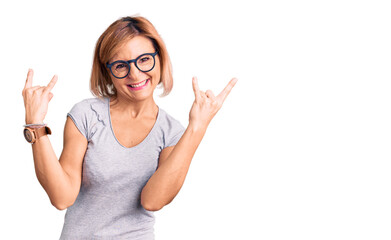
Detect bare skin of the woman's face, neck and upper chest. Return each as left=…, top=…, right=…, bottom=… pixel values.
left=110, top=36, right=160, bottom=148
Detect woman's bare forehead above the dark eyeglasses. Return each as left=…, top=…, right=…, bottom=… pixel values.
left=113, top=36, right=155, bottom=60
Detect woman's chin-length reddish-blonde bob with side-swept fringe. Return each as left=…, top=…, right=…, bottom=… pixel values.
left=90, top=17, right=173, bottom=98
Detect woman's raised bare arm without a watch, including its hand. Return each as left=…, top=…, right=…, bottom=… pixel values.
left=141, top=78, right=237, bottom=211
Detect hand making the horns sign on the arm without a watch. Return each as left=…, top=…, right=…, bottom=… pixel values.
left=189, top=77, right=238, bottom=130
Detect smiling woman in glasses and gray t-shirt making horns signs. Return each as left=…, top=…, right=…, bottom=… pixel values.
left=23, top=17, right=237, bottom=239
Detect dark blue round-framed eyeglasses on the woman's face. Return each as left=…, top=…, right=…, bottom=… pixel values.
left=106, top=51, right=157, bottom=79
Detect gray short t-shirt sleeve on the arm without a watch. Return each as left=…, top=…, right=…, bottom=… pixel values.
left=164, top=110, right=185, bottom=148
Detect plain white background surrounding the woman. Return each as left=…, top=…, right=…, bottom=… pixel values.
left=0, top=0, right=391, bottom=240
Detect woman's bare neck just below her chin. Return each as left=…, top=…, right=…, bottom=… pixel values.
left=110, top=96, right=158, bottom=118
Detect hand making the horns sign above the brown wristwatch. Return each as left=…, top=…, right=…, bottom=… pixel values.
left=22, top=69, right=58, bottom=124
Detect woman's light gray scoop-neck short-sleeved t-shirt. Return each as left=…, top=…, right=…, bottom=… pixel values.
left=60, top=98, right=184, bottom=240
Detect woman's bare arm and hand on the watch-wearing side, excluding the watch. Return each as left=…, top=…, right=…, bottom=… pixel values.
left=23, top=70, right=87, bottom=210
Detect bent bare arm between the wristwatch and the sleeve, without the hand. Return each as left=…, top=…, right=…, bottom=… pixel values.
left=32, top=117, right=87, bottom=210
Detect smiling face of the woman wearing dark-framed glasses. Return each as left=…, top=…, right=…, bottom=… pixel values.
left=109, top=36, right=160, bottom=101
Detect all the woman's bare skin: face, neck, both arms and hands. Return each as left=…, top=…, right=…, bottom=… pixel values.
left=22, top=36, right=237, bottom=211
